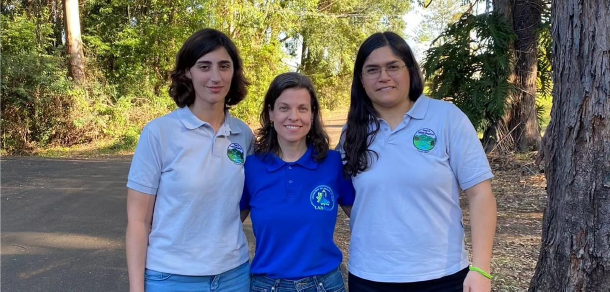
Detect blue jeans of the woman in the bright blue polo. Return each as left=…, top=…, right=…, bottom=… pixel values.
left=250, top=269, right=345, bottom=292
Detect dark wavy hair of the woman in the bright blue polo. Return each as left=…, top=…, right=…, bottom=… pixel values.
left=254, top=72, right=329, bottom=162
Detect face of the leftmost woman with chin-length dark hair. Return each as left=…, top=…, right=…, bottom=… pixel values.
left=186, top=47, right=234, bottom=106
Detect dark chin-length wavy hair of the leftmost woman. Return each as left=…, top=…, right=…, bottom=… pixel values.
left=169, top=28, right=250, bottom=109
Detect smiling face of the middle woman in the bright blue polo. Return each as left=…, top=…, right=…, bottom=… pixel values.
left=269, top=88, right=313, bottom=146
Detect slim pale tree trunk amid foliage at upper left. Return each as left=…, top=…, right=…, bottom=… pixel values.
left=64, top=0, right=85, bottom=84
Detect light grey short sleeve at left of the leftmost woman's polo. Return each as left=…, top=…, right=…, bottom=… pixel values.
left=127, top=126, right=162, bottom=195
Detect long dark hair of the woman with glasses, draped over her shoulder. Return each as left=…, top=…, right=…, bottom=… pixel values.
left=342, top=32, right=424, bottom=176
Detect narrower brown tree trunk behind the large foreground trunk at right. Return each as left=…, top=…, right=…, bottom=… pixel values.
left=506, top=0, right=542, bottom=152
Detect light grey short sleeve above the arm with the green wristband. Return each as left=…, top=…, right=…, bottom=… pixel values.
left=448, top=110, right=493, bottom=190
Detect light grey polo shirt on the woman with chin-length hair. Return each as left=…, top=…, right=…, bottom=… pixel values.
left=127, top=107, right=253, bottom=276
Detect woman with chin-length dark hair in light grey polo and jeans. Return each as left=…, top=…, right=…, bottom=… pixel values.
left=126, top=29, right=253, bottom=292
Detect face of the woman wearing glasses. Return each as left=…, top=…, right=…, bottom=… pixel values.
left=360, top=46, right=411, bottom=110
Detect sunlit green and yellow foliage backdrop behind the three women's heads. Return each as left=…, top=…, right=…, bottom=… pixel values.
left=0, top=0, right=410, bottom=152
